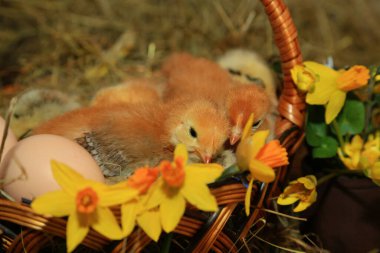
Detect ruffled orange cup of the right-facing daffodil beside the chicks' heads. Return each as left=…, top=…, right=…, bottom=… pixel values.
left=256, top=140, right=289, bottom=168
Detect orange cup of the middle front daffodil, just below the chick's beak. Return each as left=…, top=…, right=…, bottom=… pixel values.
left=160, top=157, right=185, bottom=188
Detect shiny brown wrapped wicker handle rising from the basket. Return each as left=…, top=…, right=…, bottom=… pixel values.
left=261, top=0, right=305, bottom=154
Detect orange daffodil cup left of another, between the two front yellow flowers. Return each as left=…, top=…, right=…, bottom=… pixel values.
left=127, top=167, right=159, bottom=194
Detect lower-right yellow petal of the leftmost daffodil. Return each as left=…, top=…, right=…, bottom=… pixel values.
left=91, top=207, right=123, bottom=240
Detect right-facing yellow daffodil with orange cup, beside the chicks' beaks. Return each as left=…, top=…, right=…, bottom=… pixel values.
left=236, top=114, right=289, bottom=215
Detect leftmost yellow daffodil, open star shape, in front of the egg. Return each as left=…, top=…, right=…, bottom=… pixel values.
left=31, top=161, right=138, bottom=252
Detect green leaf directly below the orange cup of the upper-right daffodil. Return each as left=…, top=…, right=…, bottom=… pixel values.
left=337, top=100, right=365, bottom=135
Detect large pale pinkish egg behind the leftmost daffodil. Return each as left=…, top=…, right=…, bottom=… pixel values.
left=0, top=134, right=104, bottom=202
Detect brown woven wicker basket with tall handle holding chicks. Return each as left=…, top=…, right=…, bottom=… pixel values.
left=0, top=0, right=305, bottom=253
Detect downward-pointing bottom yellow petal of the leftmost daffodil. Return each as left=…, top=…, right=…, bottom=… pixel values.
left=66, top=212, right=89, bottom=252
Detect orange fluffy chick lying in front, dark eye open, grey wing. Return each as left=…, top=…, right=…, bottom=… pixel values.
left=34, top=97, right=228, bottom=180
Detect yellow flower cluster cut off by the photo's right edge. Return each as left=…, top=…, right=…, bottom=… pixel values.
left=338, top=131, right=380, bottom=171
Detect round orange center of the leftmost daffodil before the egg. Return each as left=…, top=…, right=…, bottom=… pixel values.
left=76, top=187, right=99, bottom=214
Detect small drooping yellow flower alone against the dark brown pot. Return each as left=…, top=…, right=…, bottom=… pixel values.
left=277, top=175, right=317, bottom=212
